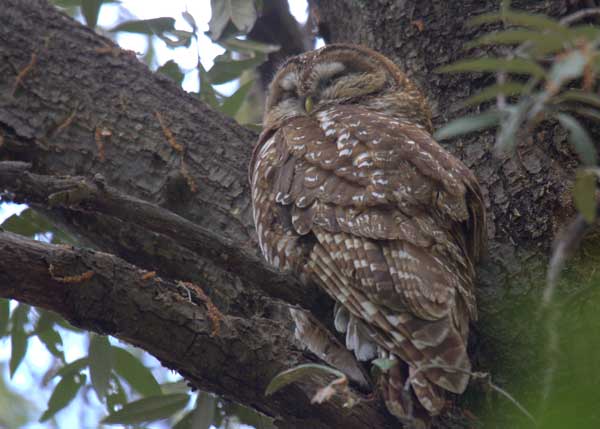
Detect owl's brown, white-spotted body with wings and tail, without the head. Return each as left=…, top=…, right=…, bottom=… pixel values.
left=250, top=105, right=485, bottom=413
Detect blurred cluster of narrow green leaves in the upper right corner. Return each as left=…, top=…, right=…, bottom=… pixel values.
left=436, top=2, right=600, bottom=227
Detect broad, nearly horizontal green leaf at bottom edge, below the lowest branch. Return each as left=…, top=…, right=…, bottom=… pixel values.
left=102, top=393, right=190, bottom=425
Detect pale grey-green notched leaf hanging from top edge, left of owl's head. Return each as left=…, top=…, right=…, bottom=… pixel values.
left=208, top=0, right=257, bottom=41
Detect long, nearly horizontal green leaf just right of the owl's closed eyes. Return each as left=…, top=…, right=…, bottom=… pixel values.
left=436, top=57, right=546, bottom=78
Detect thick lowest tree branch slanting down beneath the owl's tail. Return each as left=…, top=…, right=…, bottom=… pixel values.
left=0, top=232, right=394, bottom=429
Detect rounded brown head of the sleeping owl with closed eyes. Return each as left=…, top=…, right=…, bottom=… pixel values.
left=263, top=44, right=431, bottom=130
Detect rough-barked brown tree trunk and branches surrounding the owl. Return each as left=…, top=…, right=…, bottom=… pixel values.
left=0, top=0, right=597, bottom=428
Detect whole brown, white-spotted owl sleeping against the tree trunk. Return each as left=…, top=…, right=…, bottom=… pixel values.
left=250, top=44, right=486, bottom=418
